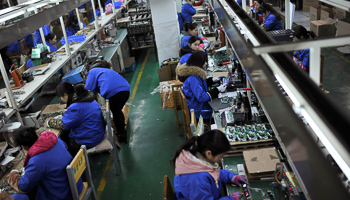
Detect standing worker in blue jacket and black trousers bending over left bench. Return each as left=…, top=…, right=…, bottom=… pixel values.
left=85, top=60, right=130, bottom=143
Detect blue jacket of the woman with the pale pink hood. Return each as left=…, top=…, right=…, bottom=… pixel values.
left=174, top=170, right=235, bottom=200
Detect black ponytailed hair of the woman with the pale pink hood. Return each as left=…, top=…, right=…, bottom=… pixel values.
left=171, top=130, right=231, bottom=167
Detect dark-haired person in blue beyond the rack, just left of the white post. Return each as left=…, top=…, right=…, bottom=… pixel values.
left=258, top=3, right=283, bottom=31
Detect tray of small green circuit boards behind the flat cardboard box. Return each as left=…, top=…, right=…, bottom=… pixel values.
left=225, top=124, right=274, bottom=142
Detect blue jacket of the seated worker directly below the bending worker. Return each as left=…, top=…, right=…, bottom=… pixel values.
left=62, top=92, right=106, bottom=147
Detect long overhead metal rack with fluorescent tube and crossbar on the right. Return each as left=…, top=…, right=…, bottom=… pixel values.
left=211, top=0, right=350, bottom=200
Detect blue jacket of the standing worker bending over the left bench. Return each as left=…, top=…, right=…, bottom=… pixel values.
left=85, top=67, right=130, bottom=99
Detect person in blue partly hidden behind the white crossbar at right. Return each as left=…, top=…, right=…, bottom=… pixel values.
left=293, top=25, right=316, bottom=73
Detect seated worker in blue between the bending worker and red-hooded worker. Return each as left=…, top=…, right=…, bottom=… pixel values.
left=56, top=81, right=106, bottom=156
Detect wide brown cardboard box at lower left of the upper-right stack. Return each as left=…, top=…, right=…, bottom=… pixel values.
left=310, top=19, right=335, bottom=37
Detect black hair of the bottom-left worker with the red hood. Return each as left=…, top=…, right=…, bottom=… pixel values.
left=12, top=126, right=38, bottom=148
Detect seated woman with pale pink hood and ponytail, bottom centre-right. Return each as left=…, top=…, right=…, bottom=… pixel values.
left=172, top=130, right=246, bottom=200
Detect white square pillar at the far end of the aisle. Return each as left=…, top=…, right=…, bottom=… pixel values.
left=150, top=0, right=180, bottom=63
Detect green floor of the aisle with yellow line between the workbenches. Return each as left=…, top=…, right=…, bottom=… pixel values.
left=91, top=49, right=184, bottom=200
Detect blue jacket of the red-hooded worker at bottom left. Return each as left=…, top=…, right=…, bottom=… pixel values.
left=18, top=139, right=83, bottom=200
